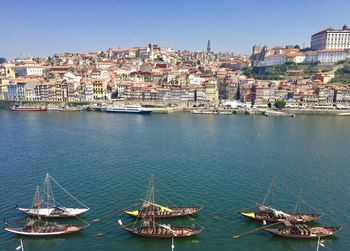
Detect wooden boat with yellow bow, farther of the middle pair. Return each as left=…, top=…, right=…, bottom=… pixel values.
left=124, top=201, right=203, bottom=218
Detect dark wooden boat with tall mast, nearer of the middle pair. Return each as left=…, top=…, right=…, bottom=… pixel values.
left=118, top=179, right=203, bottom=238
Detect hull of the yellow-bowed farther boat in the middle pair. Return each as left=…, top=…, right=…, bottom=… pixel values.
left=124, top=206, right=203, bottom=218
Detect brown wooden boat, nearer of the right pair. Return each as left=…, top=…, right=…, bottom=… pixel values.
left=264, top=222, right=342, bottom=239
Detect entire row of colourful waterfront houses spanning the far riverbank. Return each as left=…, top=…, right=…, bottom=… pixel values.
left=0, top=75, right=350, bottom=104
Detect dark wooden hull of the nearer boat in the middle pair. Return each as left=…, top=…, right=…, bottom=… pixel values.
left=123, top=226, right=203, bottom=239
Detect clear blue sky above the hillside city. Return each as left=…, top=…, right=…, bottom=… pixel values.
left=0, top=0, right=350, bottom=59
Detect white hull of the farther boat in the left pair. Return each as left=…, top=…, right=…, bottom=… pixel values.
left=17, top=208, right=89, bottom=218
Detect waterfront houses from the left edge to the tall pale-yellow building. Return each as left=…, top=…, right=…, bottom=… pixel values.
left=0, top=79, right=218, bottom=103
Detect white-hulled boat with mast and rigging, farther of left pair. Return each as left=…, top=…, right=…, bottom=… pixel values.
left=16, top=174, right=89, bottom=218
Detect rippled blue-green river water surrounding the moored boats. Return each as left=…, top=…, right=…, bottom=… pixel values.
left=0, top=111, right=350, bottom=251
